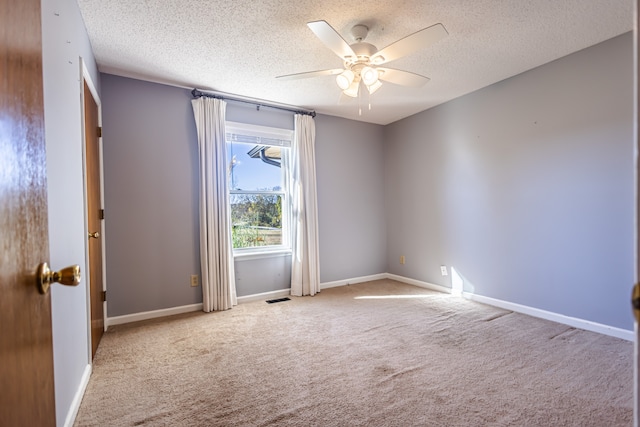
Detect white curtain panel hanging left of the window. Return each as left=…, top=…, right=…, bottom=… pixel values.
left=191, top=97, right=238, bottom=312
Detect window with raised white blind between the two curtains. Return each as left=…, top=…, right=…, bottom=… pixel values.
left=225, top=122, right=293, bottom=253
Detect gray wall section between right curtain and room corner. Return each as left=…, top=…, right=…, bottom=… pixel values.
left=316, top=115, right=387, bottom=283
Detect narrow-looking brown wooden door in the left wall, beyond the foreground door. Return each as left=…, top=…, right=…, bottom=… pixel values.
left=84, top=81, right=104, bottom=358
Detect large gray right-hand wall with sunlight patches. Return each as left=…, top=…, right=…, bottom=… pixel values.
left=385, top=33, right=634, bottom=330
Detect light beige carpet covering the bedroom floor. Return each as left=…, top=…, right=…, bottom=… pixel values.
left=76, top=280, right=633, bottom=427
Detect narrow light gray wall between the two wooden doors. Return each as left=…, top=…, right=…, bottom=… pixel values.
left=42, top=0, right=100, bottom=426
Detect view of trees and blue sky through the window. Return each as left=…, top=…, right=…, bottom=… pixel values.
left=227, top=137, right=286, bottom=249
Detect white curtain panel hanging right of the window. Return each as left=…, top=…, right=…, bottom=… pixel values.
left=291, top=114, right=320, bottom=296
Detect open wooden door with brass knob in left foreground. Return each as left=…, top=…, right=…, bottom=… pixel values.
left=0, top=0, right=56, bottom=426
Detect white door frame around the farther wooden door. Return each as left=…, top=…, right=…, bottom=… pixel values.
left=79, top=57, right=107, bottom=365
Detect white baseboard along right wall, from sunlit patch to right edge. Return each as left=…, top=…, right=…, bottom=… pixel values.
left=462, top=292, right=635, bottom=341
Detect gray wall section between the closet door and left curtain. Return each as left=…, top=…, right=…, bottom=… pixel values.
left=101, top=74, right=202, bottom=317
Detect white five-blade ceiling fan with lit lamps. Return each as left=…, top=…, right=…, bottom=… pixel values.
left=276, top=21, right=448, bottom=98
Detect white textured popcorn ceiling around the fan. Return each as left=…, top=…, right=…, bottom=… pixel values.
left=78, top=0, right=633, bottom=124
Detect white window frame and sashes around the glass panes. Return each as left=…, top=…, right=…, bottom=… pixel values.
left=225, top=121, right=294, bottom=259
